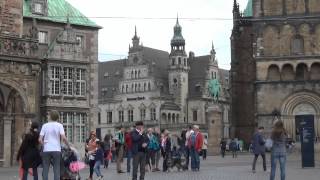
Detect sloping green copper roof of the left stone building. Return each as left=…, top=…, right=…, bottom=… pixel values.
left=23, top=0, right=101, bottom=28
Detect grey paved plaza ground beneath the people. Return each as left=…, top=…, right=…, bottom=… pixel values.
left=0, top=155, right=320, bottom=180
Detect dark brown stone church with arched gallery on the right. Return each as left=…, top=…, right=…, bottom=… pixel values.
left=230, top=0, right=320, bottom=143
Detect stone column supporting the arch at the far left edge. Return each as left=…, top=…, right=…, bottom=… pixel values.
left=3, top=116, right=13, bottom=167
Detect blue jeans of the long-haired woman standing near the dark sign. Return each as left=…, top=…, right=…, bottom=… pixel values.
left=270, top=153, right=287, bottom=180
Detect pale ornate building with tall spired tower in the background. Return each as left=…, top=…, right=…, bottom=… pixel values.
left=99, top=19, right=230, bottom=141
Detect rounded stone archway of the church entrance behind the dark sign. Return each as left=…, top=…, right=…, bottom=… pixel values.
left=281, top=92, right=320, bottom=139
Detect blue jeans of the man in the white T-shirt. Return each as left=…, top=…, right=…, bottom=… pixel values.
left=42, top=151, right=61, bottom=180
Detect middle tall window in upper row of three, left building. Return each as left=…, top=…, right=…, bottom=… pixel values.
left=62, top=67, right=73, bottom=96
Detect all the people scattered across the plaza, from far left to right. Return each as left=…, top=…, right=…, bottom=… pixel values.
left=17, top=111, right=288, bottom=180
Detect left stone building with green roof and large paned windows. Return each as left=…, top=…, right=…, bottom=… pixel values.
left=0, top=0, right=100, bottom=166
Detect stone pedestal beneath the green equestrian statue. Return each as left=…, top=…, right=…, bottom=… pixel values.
left=207, top=104, right=223, bottom=155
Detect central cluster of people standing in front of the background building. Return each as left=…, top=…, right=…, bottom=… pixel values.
left=85, top=121, right=208, bottom=180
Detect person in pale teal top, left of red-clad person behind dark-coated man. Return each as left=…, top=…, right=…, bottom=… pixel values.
left=115, top=126, right=125, bottom=173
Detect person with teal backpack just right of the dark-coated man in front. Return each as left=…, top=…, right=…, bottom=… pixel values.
left=147, top=128, right=159, bottom=172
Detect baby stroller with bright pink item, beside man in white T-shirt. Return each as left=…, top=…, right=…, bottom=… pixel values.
left=60, top=147, right=85, bottom=180
